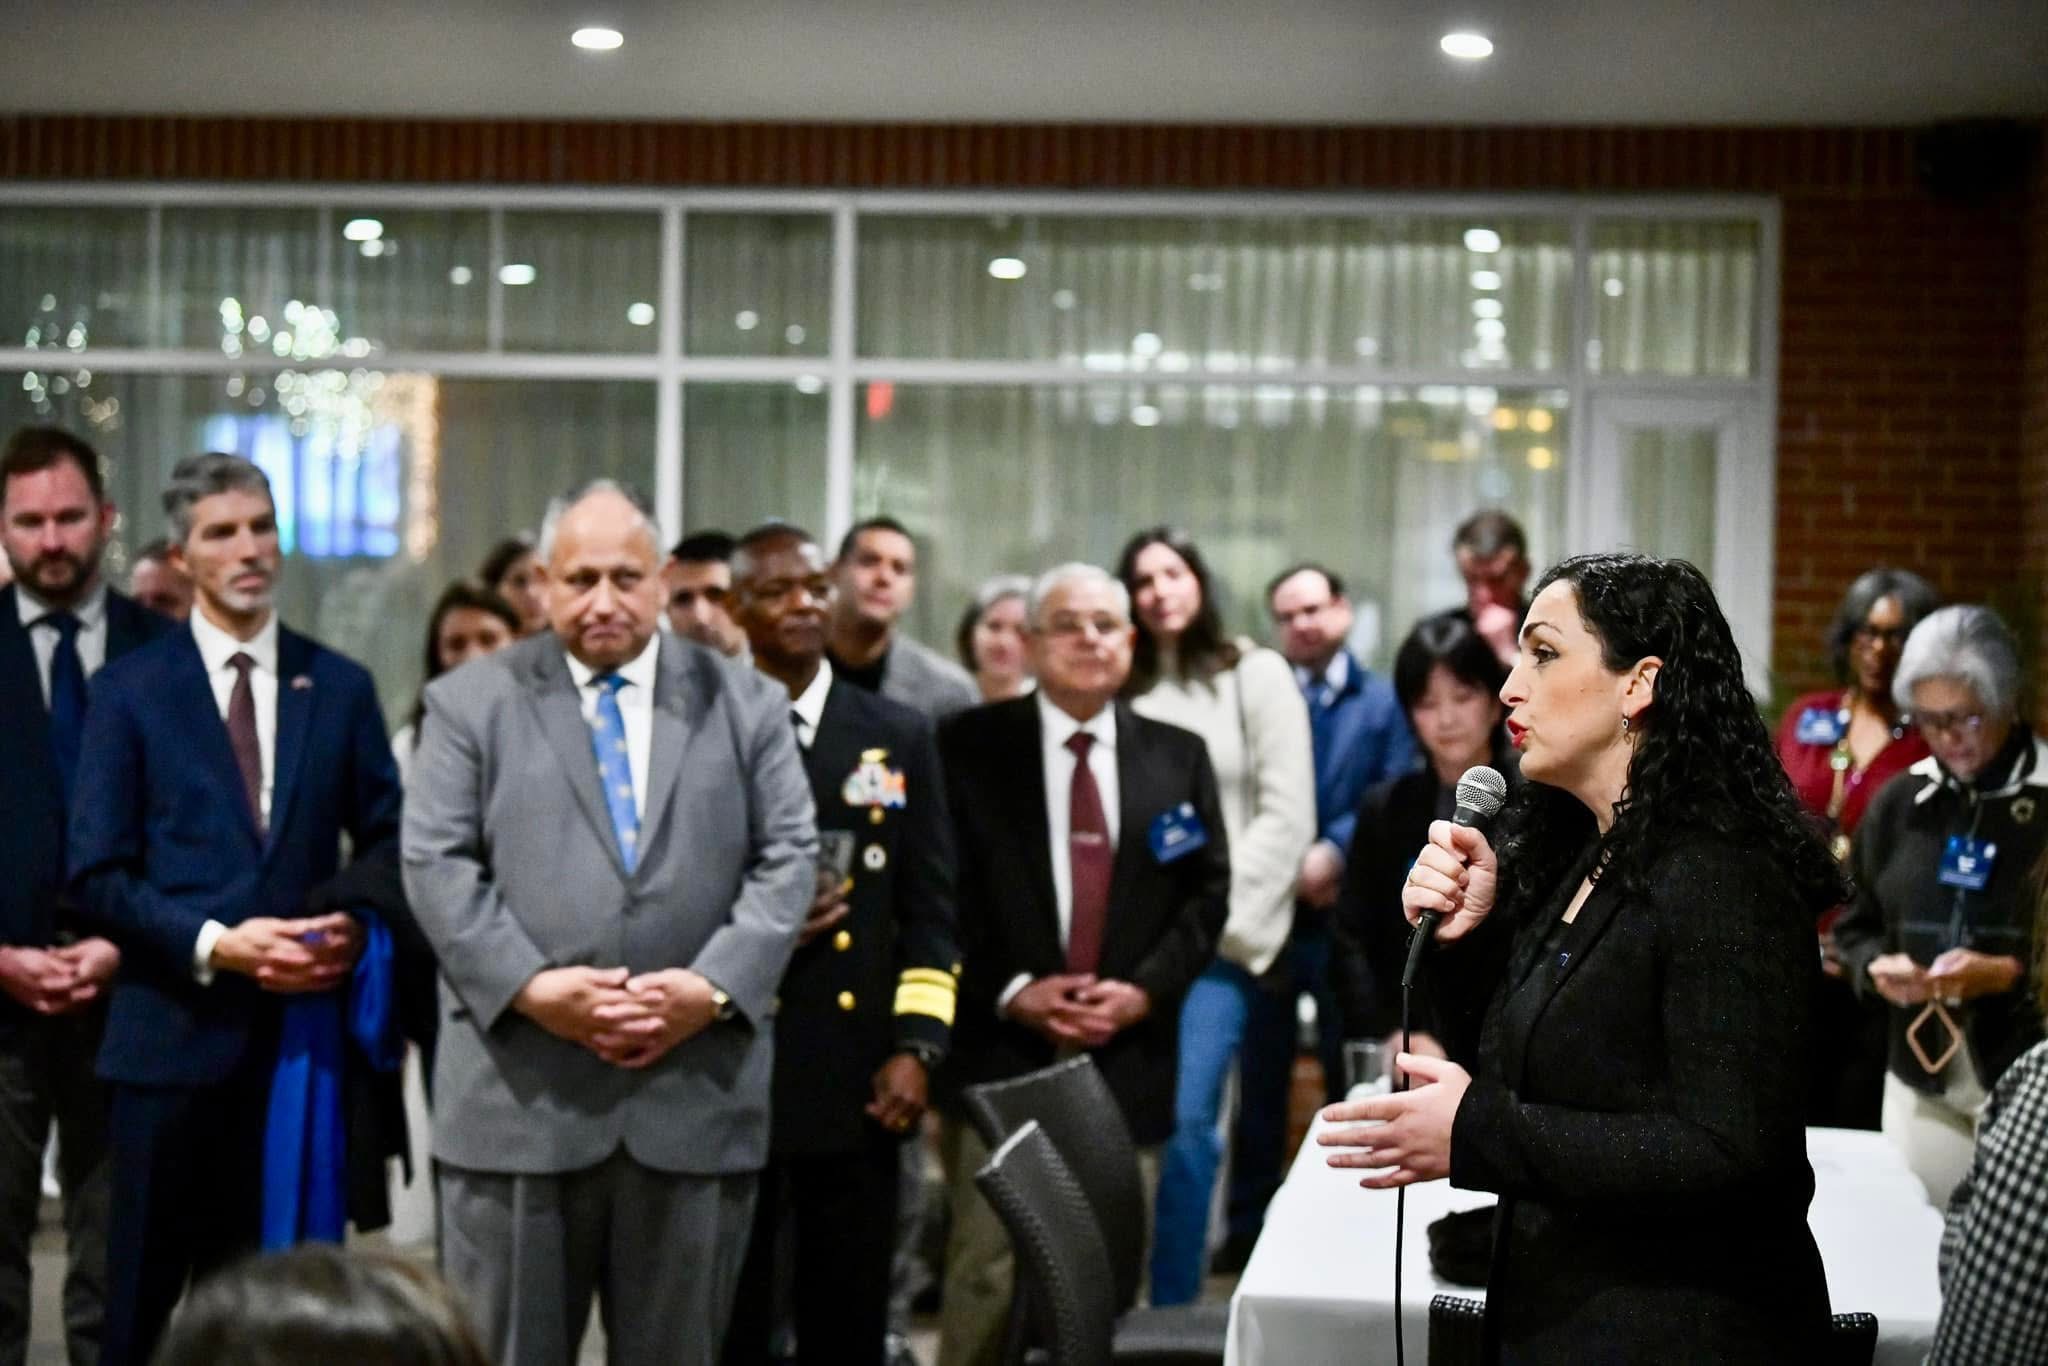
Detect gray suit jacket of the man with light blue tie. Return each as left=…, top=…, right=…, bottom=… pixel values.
left=401, top=633, right=817, bottom=1176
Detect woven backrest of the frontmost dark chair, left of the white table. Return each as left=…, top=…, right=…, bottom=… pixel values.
left=975, top=1122, right=1116, bottom=1366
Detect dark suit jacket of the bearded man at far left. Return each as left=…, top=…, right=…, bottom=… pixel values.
left=0, top=584, right=172, bottom=966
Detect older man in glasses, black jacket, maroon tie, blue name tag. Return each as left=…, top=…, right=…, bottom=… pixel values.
left=940, top=565, right=1231, bottom=1366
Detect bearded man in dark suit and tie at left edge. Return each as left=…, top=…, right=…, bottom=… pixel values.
left=0, top=428, right=170, bottom=1366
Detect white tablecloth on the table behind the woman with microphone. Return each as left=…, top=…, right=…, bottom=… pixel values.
left=1223, top=1120, right=1942, bottom=1366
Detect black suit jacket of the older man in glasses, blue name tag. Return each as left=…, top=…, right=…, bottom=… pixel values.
left=938, top=696, right=1231, bottom=1145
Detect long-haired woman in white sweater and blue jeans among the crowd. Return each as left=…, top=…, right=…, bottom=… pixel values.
left=1116, top=526, right=1315, bottom=1305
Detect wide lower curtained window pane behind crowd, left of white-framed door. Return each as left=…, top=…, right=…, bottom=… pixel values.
left=854, top=383, right=1569, bottom=664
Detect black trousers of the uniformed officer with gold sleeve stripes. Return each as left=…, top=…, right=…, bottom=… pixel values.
left=725, top=1126, right=901, bottom=1366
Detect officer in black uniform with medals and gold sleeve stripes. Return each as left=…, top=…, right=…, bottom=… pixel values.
left=725, top=524, right=958, bottom=1366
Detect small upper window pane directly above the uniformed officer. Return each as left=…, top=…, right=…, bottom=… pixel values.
left=682, top=213, right=831, bottom=356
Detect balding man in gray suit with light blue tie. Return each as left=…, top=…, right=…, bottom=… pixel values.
left=403, top=481, right=817, bottom=1366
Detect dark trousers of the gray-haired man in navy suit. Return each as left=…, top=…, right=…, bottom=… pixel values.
left=100, top=1042, right=276, bottom=1366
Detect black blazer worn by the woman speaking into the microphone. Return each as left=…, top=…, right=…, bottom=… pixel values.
left=1432, top=836, right=1835, bottom=1362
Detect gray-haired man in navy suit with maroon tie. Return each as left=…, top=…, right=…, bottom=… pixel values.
left=70, top=455, right=399, bottom=1366
